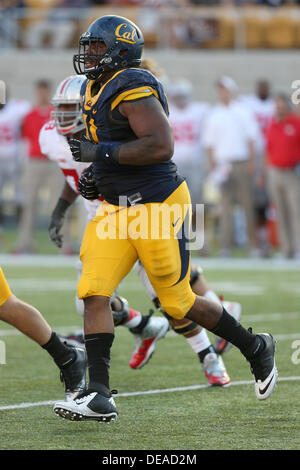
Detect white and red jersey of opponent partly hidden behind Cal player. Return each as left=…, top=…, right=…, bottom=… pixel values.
left=39, top=121, right=101, bottom=220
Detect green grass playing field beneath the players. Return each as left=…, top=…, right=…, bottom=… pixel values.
left=0, top=258, right=300, bottom=450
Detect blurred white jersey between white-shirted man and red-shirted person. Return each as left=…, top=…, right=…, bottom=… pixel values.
left=239, top=95, right=275, bottom=153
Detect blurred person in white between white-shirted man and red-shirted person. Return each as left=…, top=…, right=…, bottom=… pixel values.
left=240, top=80, right=275, bottom=256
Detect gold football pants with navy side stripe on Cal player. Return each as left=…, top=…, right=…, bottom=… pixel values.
left=78, top=182, right=195, bottom=319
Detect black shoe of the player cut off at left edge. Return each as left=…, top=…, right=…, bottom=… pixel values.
left=60, top=347, right=87, bottom=401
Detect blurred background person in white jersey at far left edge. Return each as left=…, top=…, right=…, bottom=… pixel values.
left=0, top=94, right=30, bottom=244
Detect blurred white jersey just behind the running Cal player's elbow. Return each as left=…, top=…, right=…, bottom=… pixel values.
left=169, top=102, right=209, bottom=164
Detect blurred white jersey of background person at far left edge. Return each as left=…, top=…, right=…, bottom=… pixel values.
left=0, top=100, right=31, bottom=161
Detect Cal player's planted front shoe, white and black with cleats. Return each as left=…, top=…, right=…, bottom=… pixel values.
left=53, top=390, right=118, bottom=423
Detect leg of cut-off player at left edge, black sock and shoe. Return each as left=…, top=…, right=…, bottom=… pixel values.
left=0, top=267, right=86, bottom=401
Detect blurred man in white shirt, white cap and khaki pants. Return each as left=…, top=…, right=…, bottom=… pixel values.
left=204, top=76, right=257, bottom=256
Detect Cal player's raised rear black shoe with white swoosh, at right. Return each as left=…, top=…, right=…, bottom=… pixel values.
left=249, top=333, right=278, bottom=400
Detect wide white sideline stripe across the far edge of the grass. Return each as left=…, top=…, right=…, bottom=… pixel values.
left=0, top=254, right=300, bottom=271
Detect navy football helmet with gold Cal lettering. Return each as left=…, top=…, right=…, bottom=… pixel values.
left=73, top=15, right=144, bottom=80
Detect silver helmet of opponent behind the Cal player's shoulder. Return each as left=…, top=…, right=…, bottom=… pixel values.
left=51, top=75, right=86, bottom=135
